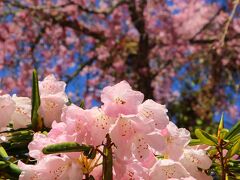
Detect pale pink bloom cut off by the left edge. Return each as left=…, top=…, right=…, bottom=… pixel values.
left=0, top=94, right=16, bottom=131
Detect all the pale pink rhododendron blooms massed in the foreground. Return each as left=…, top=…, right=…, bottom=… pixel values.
left=0, top=75, right=212, bottom=180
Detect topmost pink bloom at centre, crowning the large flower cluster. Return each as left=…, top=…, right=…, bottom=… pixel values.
left=101, top=81, right=144, bottom=117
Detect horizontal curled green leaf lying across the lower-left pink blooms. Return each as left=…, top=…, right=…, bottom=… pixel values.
left=42, top=142, right=93, bottom=154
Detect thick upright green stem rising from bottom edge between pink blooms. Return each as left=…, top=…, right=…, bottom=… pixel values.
left=103, top=134, right=113, bottom=180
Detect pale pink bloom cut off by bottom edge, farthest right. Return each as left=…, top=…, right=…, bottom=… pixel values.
left=150, top=159, right=190, bottom=180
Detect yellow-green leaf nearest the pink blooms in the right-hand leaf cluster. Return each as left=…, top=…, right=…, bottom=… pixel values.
left=195, top=129, right=218, bottom=146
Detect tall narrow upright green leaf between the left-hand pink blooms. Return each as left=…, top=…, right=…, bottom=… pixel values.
left=31, top=69, right=43, bottom=132
